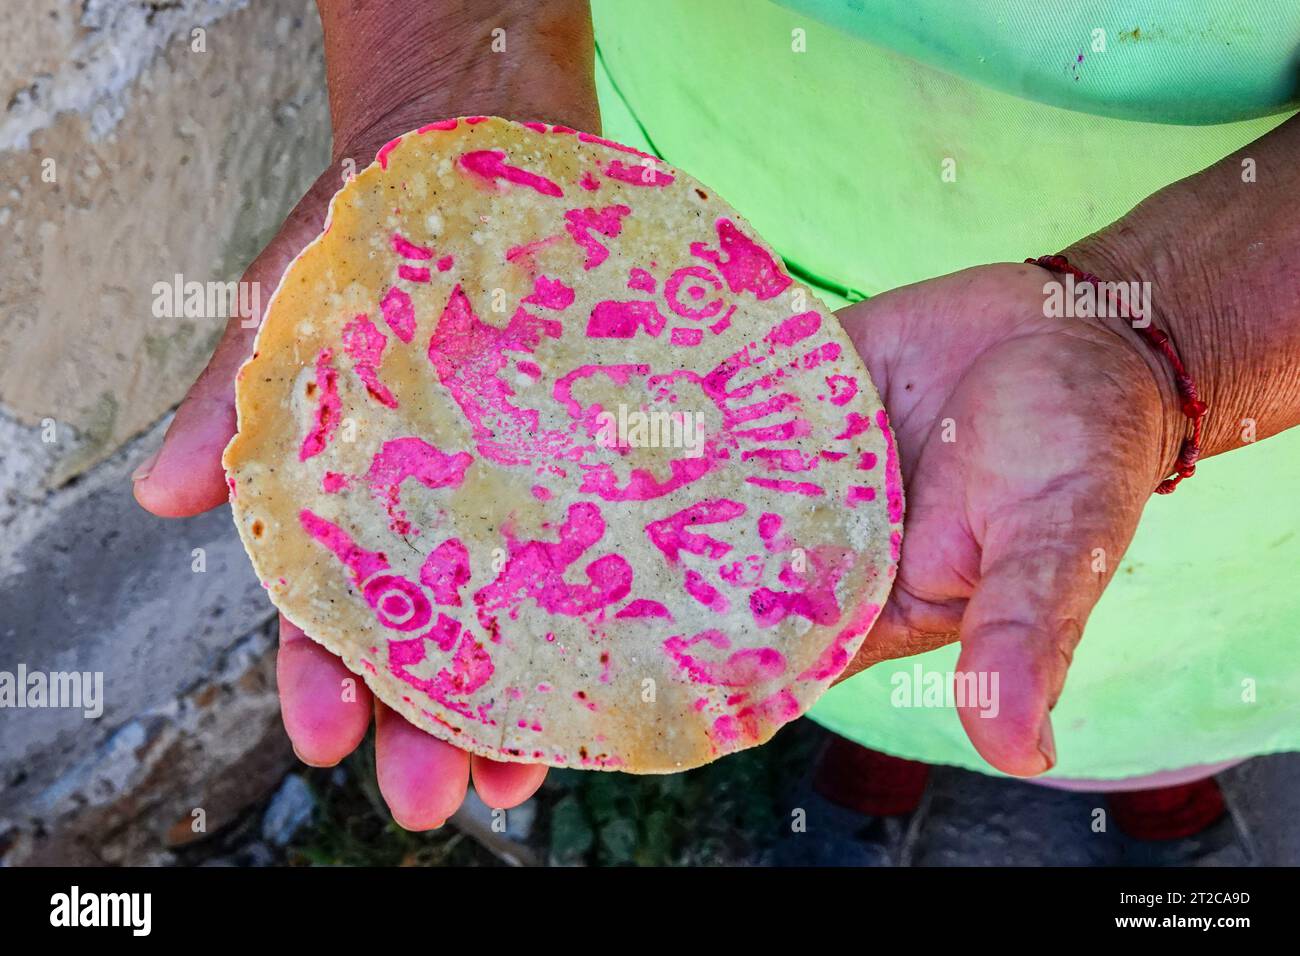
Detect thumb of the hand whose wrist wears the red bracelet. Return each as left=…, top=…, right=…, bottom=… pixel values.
left=957, top=502, right=1132, bottom=777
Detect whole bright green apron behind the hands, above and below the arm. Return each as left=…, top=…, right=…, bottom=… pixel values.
left=593, top=0, right=1300, bottom=778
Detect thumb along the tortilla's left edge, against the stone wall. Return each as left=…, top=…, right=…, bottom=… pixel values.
left=131, top=184, right=339, bottom=518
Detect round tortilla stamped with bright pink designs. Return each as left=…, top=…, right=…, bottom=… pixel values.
left=224, top=117, right=904, bottom=773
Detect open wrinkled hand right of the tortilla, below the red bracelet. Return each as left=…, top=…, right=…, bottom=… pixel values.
left=840, top=264, right=1177, bottom=775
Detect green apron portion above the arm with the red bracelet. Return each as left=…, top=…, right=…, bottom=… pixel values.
left=593, top=0, right=1300, bottom=297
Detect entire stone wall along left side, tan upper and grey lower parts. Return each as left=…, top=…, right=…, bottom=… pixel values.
left=0, top=0, right=329, bottom=862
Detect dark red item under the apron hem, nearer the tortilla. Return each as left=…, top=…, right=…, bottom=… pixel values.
left=813, top=736, right=930, bottom=817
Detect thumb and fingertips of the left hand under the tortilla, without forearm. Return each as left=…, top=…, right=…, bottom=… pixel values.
left=135, top=153, right=546, bottom=830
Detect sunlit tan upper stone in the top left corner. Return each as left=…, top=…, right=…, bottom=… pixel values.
left=0, top=0, right=329, bottom=486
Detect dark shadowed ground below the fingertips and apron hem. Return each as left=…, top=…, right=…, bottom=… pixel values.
left=188, top=721, right=1300, bottom=866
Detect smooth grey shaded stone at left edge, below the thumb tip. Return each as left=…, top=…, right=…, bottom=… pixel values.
left=0, top=416, right=273, bottom=806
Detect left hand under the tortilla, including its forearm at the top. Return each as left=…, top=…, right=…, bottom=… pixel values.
left=134, top=0, right=601, bottom=830
